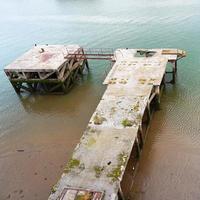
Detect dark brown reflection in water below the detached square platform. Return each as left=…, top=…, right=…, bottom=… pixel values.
left=18, top=77, right=94, bottom=115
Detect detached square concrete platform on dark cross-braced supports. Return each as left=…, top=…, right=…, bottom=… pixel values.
left=4, top=45, right=88, bottom=93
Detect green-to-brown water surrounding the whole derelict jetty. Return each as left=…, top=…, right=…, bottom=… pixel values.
left=0, top=0, right=200, bottom=200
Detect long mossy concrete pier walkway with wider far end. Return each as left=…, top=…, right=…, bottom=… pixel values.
left=49, top=49, right=185, bottom=200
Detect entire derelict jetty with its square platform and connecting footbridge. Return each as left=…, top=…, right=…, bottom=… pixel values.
left=5, top=45, right=186, bottom=200
